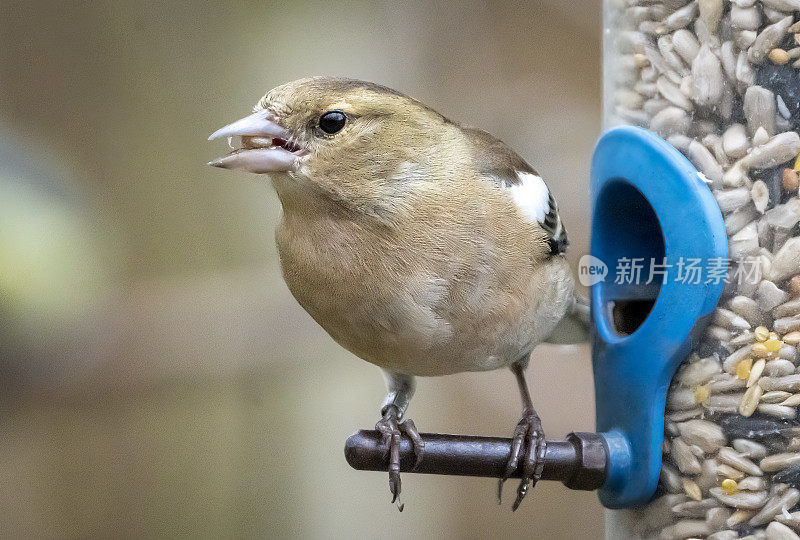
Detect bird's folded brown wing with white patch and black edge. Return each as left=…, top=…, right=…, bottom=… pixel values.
left=464, top=128, right=569, bottom=254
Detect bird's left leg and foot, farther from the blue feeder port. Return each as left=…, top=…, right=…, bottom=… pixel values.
left=375, top=371, right=425, bottom=512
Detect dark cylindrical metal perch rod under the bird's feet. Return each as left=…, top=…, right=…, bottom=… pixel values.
left=344, top=430, right=607, bottom=490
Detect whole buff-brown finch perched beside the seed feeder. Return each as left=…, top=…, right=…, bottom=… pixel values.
left=209, top=76, right=586, bottom=511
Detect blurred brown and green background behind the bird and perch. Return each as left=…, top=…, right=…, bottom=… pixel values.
left=0, top=0, right=602, bottom=539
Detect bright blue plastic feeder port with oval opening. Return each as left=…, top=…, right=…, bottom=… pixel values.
left=591, top=126, right=728, bottom=508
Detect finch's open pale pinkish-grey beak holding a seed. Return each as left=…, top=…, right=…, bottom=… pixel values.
left=208, top=110, right=306, bottom=174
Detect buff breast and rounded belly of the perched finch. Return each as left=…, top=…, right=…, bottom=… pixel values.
left=276, top=200, right=572, bottom=375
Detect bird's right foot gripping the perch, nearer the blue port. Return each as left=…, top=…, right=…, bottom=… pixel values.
left=497, top=408, right=546, bottom=510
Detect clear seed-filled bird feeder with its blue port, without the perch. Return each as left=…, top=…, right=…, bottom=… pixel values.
left=604, top=0, right=800, bottom=539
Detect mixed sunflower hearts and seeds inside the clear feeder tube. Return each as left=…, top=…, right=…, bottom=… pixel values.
left=605, top=0, right=800, bottom=540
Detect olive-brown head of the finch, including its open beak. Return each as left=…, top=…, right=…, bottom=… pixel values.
left=209, top=77, right=461, bottom=218
